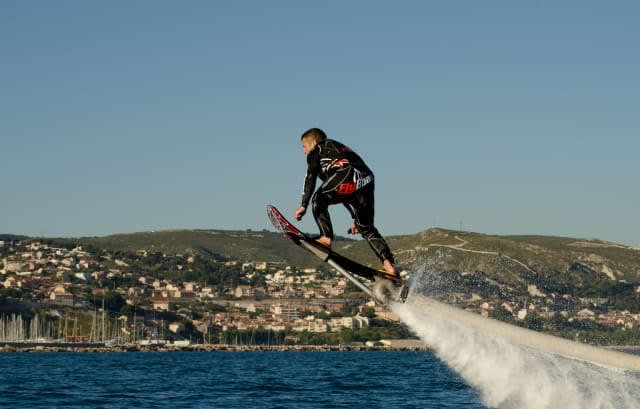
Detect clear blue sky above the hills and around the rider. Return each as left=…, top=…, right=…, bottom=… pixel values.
left=0, top=0, right=640, bottom=246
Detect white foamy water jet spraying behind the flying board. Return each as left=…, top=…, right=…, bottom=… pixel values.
left=392, top=270, right=640, bottom=409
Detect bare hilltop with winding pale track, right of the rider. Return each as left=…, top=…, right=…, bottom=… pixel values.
left=390, top=229, right=640, bottom=282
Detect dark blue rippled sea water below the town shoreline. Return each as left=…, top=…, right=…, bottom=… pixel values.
left=0, top=352, right=485, bottom=409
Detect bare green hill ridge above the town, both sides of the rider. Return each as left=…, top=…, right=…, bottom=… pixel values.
left=41, top=228, right=640, bottom=291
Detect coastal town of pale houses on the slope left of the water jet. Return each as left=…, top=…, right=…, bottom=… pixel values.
left=0, top=236, right=410, bottom=344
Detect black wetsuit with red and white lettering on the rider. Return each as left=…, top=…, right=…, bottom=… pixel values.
left=302, top=139, right=394, bottom=263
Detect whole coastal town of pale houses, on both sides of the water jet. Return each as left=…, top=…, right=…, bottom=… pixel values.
left=0, top=239, right=640, bottom=346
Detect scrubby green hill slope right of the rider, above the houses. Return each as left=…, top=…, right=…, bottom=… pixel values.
left=390, top=229, right=640, bottom=298
